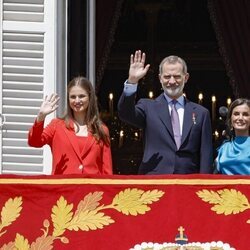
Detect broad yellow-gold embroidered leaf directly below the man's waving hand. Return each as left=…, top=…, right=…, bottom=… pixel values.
left=112, top=188, right=150, bottom=216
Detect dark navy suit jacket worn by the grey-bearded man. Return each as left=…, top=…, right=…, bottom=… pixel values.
left=118, top=93, right=213, bottom=174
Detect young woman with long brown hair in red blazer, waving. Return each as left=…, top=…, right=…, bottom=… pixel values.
left=28, top=77, right=112, bottom=175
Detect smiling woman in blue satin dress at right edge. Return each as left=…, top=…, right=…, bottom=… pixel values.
left=216, top=98, right=250, bottom=175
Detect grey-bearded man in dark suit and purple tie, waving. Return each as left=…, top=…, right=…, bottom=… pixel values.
left=118, top=50, right=213, bottom=174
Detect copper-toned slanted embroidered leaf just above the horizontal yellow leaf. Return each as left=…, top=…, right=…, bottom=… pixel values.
left=75, top=192, right=103, bottom=215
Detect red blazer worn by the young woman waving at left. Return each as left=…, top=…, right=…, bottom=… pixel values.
left=28, top=119, right=112, bottom=174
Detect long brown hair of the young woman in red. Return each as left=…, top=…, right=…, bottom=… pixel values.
left=63, top=76, right=110, bottom=145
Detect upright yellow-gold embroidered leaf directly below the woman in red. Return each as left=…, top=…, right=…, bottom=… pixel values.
left=51, top=196, right=73, bottom=237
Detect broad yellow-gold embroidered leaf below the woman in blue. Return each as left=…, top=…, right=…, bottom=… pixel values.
left=197, top=189, right=250, bottom=215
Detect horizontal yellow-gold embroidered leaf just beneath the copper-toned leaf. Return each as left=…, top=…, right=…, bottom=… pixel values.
left=67, top=211, right=114, bottom=231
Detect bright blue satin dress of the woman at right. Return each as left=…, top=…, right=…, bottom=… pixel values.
left=217, top=136, right=250, bottom=175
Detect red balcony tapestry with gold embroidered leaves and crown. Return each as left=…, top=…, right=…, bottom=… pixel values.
left=0, top=175, right=250, bottom=250
